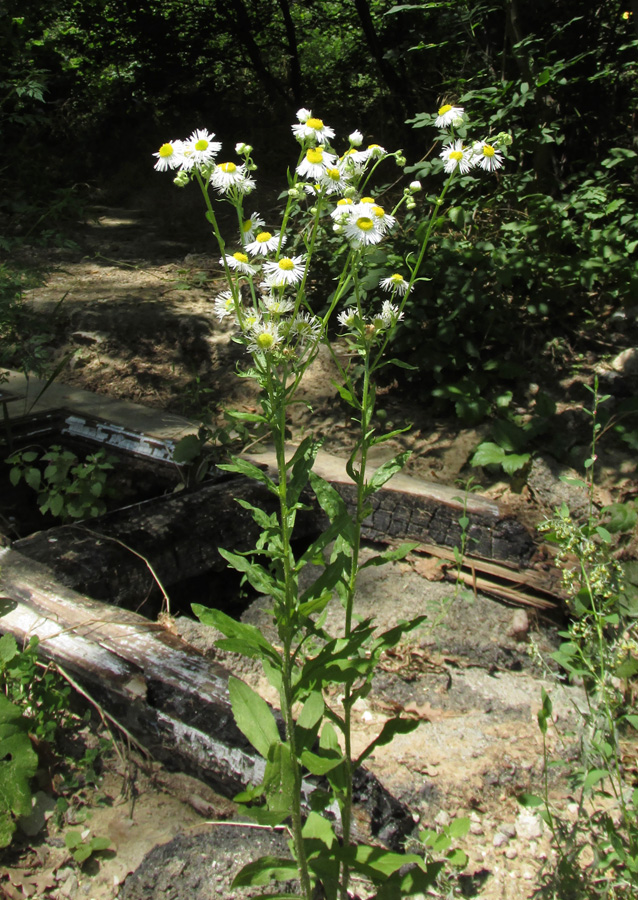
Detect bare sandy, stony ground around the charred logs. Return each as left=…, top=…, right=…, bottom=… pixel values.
left=0, top=208, right=636, bottom=900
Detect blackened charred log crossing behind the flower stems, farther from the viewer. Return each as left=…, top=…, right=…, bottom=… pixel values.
left=14, top=446, right=551, bottom=612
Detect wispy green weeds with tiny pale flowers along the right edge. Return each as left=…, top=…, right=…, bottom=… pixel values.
left=523, top=381, right=638, bottom=900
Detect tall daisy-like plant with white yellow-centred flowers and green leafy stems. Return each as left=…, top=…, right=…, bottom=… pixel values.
left=155, top=105, right=509, bottom=900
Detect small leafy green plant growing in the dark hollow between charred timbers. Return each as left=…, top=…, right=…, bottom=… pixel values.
left=5, top=445, right=116, bottom=521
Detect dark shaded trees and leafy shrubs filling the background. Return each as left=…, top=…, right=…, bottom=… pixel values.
left=0, top=0, right=638, bottom=414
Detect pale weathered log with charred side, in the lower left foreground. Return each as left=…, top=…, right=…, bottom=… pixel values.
left=0, top=549, right=414, bottom=848
